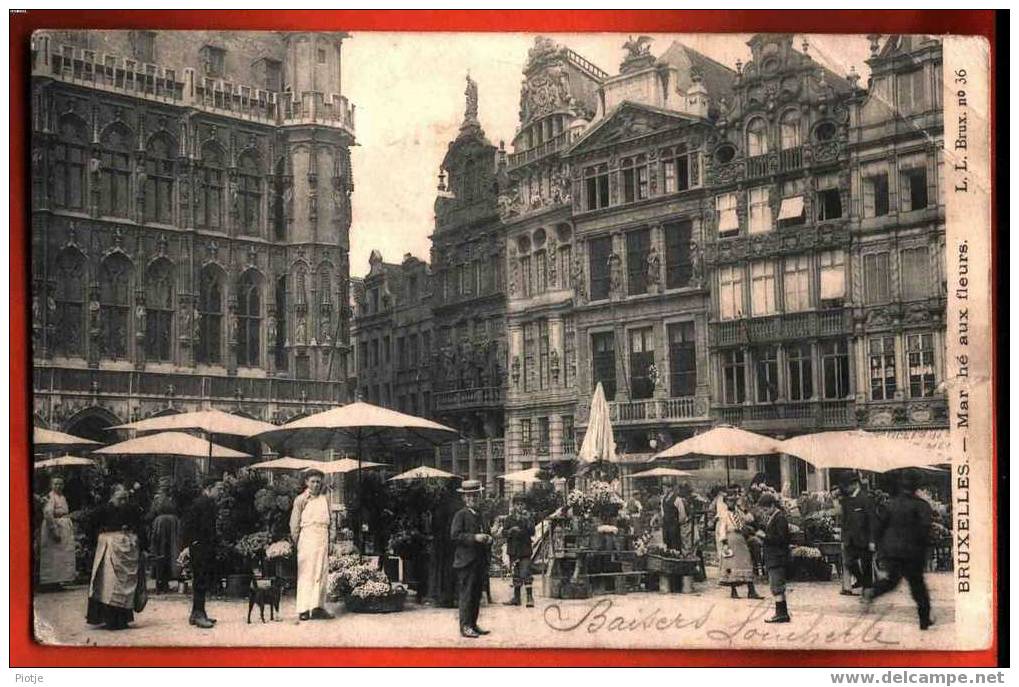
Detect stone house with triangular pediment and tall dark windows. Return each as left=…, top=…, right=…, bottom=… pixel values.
left=564, top=39, right=735, bottom=477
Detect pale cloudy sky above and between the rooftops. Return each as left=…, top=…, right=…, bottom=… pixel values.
left=342, top=33, right=870, bottom=276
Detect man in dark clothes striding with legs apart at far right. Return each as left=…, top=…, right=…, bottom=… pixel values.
left=863, top=472, right=934, bottom=630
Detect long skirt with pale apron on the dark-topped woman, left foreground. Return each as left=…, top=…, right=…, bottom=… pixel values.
left=86, top=532, right=143, bottom=626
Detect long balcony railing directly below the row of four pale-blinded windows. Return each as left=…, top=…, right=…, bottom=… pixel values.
left=709, top=308, right=852, bottom=346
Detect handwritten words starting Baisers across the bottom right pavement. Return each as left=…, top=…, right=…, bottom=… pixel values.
left=544, top=598, right=899, bottom=648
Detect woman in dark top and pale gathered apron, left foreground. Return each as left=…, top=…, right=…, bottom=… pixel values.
left=86, top=484, right=144, bottom=630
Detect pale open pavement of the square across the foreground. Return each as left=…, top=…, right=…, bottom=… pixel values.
left=35, top=574, right=956, bottom=649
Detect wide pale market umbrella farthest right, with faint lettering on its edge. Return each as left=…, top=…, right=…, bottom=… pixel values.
left=779, top=429, right=952, bottom=472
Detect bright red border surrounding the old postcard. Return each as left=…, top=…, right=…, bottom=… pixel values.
left=9, top=9, right=1000, bottom=668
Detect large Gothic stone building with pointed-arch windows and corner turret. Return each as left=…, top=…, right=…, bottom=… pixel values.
left=32, top=31, right=354, bottom=438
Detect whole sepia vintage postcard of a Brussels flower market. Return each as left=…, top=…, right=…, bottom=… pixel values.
left=25, top=30, right=997, bottom=651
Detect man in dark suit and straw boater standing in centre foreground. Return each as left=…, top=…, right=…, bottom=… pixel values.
left=449, top=479, right=492, bottom=639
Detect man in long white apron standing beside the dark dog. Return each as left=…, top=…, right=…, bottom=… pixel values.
left=290, top=468, right=332, bottom=621
